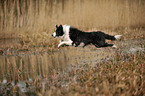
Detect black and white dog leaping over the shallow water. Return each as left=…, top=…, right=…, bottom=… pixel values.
left=52, top=25, right=122, bottom=48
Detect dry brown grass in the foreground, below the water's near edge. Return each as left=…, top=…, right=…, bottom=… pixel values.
left=0, top=50, right=145, bottom=96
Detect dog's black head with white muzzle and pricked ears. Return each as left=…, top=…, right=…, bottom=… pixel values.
left=52, top=25, right=64, bottom=38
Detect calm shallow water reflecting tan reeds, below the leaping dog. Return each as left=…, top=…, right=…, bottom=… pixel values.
left=0, top=46, right=113, bottom=81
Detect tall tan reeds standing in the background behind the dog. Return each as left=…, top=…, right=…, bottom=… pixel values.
left=0, top=0, right=145, bottom=39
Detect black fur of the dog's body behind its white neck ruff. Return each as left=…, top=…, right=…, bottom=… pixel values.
left=70, top=27, right=115, bottom=48
